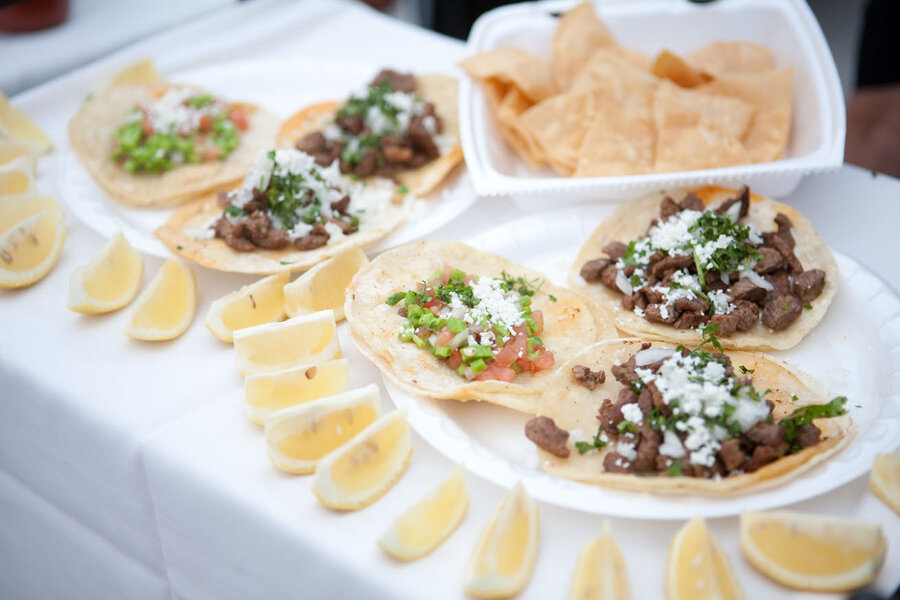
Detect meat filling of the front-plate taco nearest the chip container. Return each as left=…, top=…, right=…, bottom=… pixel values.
left=581, top=186, right=825, bottom=336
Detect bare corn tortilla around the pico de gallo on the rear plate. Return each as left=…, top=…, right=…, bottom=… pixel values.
left=68, top=81, right=279, bottom=208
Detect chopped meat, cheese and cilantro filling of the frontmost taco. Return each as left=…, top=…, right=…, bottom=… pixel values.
left=529, top=347, right=847, bottom=478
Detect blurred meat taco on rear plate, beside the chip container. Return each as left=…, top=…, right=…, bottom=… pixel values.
left=278, top=69, right=463, bottom=196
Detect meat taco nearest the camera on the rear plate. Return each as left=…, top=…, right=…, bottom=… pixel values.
left=154, top=149, right=404, bottom=273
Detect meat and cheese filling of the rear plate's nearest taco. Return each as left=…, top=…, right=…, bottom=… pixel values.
left=212, top=150, right=360, bottom=252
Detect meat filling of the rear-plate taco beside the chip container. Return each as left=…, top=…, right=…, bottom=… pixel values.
left=297, top=69, right=441, bottom=177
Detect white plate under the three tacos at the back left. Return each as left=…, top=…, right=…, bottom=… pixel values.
left=60, top=59, right=476, bottom=257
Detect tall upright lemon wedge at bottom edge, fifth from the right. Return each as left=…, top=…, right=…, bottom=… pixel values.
left=464, top=482, right=540, bottom=598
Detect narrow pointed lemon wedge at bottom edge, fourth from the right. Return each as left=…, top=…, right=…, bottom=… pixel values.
left=569, top=521, right=628, bottom=600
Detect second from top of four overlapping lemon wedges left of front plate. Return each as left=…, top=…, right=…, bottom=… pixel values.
left=244, top=358, right=350, bottom=425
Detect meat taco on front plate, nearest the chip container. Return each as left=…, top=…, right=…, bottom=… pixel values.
left=569, top=186, right=839, bottom=350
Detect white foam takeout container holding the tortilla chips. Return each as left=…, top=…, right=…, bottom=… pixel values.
left=459, top=0, right=845, bottom=205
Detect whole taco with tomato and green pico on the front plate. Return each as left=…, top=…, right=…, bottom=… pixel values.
left=345, top=241, right=615, bottom=414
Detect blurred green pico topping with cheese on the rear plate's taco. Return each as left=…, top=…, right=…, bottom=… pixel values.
left=112, top=86, right=248, bottom=173
